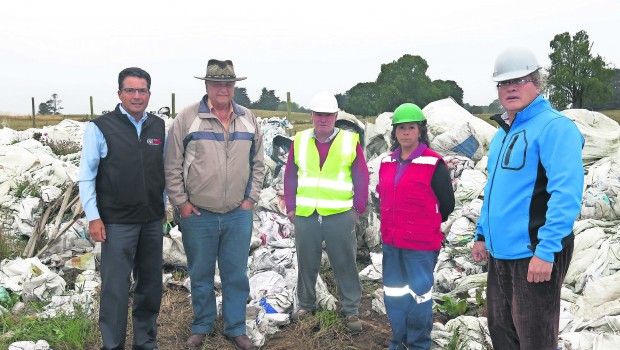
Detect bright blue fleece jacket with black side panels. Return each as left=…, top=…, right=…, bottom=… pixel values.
left=475, top=96, right=584, bottom=262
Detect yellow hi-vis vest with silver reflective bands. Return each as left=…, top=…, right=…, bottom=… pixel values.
left=293, top=129, right=359, bottom=217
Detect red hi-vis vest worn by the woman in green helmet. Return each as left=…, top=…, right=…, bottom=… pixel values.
left=377, top=149, right=444, bottom=250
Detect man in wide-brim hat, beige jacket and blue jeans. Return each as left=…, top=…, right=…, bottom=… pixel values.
left=164, top=59, right=265, bottom=350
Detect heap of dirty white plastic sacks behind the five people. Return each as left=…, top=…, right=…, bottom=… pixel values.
left=0, top=99, right=620, bottom=349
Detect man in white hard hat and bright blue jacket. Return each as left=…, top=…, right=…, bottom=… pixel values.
left=471, top=48, right=584, bottom=350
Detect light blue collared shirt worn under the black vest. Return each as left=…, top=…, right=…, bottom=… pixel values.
left=78, top=104, right=152, bottom=221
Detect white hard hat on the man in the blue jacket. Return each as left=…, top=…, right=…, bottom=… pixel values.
left=493, top=47, right=541, bottom=81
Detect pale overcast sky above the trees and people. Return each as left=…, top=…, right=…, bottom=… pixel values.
left=0, top=0, right=620, bottom=114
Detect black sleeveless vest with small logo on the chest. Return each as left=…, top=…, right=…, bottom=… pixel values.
left=93, top=107, right=166, bottom=224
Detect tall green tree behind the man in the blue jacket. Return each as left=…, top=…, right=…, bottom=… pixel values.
left=547, top=30, right=612, bottom=109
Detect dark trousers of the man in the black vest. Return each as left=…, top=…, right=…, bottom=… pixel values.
left=99, top=220, right=163, bottom=350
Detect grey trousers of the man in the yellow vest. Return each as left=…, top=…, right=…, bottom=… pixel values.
left=295, top=210, right=362, bottom=316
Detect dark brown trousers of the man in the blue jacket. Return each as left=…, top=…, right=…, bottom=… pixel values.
left=487, top=243, right=574, bottom=350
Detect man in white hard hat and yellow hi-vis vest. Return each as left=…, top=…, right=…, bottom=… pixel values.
left=284, top=91, right=368, bottom=333
